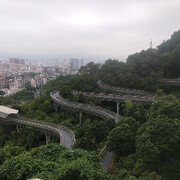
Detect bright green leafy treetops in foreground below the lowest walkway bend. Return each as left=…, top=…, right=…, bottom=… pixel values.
left=0, top=144, right=115, bottom=180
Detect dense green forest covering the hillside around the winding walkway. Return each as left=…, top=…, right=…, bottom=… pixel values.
left=0, top=30, right=180, bottom=180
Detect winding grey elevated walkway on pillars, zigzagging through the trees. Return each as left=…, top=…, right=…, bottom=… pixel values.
left=0, top=80, right=154, bottom=169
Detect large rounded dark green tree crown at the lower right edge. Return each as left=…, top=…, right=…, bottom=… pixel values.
left=136, top=116, right=180, bottom=179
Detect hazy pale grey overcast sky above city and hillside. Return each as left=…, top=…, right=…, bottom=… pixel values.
left=0, top=0, right=180, bottom=60
